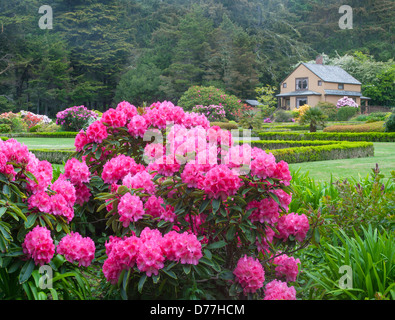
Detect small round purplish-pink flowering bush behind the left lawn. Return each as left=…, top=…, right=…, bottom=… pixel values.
left=56, top=106, right=98, bottom=132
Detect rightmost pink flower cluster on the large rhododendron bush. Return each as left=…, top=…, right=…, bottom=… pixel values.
left=277, top=213, right=310, bottom=241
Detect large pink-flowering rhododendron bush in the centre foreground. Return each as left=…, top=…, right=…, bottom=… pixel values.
left=70, top=101, right=318, bottom=299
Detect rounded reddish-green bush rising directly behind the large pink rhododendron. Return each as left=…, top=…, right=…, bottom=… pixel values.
left=178, top=86, right=242, bottom=120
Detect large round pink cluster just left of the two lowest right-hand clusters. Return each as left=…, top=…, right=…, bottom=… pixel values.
left=233, top=255, right=265, bottom=293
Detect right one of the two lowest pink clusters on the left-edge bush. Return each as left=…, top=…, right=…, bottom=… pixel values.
left=56, top=232, right=96, bottom=267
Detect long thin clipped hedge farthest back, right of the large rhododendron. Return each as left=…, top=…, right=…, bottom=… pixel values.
left=258, top=132, right=395, bottom=142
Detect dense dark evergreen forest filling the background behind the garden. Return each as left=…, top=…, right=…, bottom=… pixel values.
left=0, top=0, right=395, bottom=117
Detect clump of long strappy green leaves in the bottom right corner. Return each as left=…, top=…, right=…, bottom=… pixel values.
left=306, top=226, right=395, bottom=300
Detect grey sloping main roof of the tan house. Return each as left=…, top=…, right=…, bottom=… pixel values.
left=302, top=63, right=361, bottom=84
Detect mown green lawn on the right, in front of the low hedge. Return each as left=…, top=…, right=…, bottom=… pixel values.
left=289, top=142, right=395, bottom=181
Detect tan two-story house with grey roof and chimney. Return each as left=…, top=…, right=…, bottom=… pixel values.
left=277, top=56, right=370, bottom=110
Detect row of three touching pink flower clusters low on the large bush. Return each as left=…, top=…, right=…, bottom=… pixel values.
left=103, top=227, right=202, bottom=284
